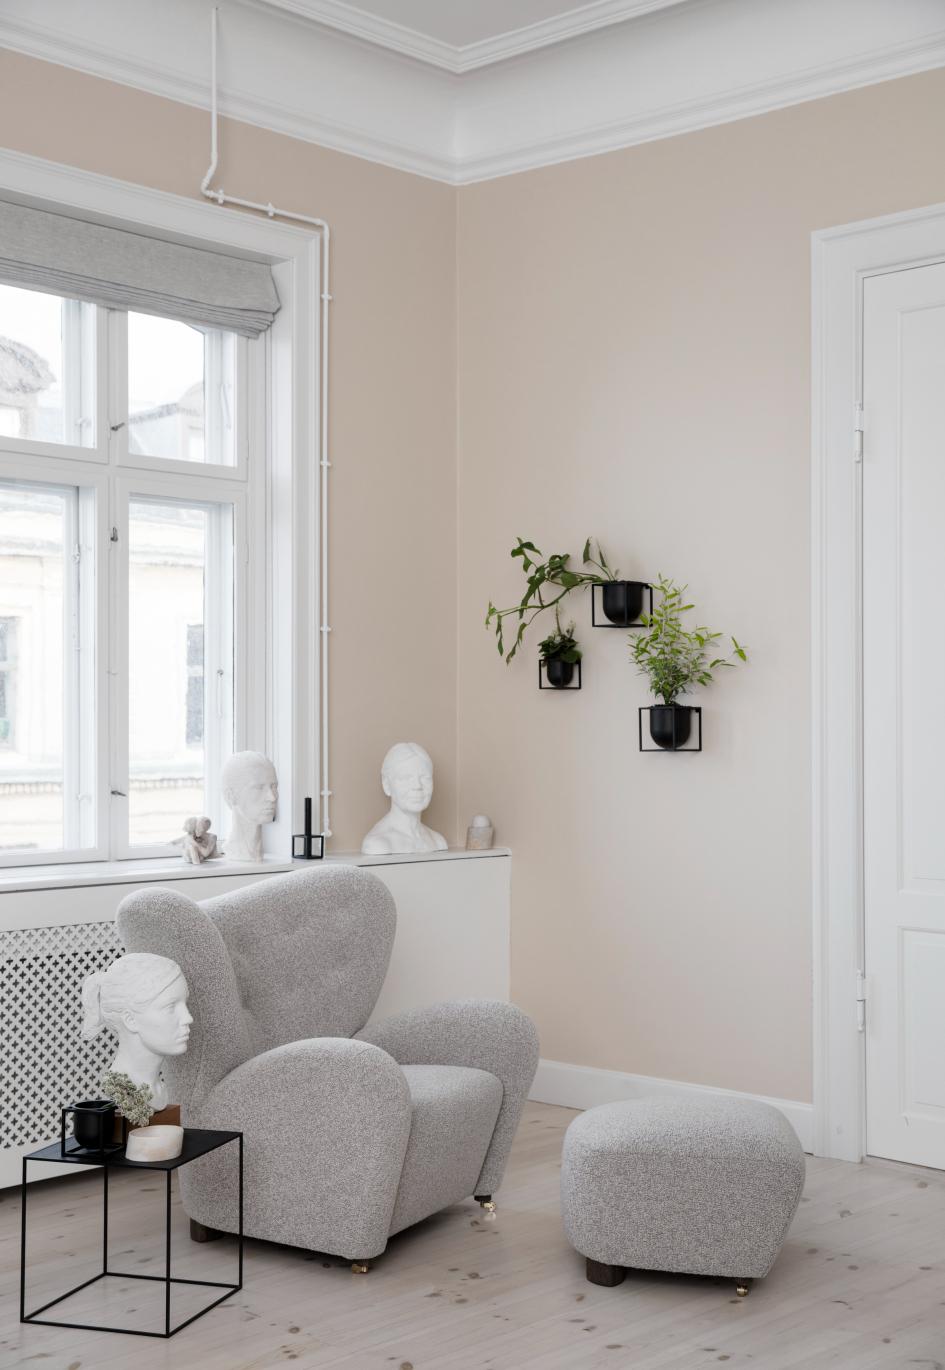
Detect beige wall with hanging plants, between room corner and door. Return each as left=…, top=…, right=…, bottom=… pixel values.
left=457, top=71, right=945, bottom=1100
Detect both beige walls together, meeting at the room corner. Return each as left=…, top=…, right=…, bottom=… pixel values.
left=0, top=53, right=945, bottom=1099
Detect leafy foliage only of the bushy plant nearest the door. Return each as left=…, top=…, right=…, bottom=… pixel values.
left=630, top=575, right=748, bottom=704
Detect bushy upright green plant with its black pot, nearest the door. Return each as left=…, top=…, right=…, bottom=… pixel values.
left=630, top=575, right=748, bottom=751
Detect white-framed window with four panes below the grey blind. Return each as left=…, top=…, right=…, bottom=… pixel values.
left=0, top=284, right=250, bottom=864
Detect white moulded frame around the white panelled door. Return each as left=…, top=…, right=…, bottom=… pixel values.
left=811, top=204, right=945, bottom=1160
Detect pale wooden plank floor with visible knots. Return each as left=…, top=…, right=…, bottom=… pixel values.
left=0, top=1104, right=945, bottom=1370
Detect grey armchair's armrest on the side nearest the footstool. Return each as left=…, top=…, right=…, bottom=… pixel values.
left=356, top=999, right=538, bottom=1195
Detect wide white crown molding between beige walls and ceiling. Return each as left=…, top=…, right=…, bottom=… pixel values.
left=0, top=0, right=945, bottom=186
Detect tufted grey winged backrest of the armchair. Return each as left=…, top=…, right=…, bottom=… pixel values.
left=118, top=864, right=397, bottom=1103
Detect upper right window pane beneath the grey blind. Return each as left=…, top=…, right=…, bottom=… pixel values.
left=127, top=314, right=236, bottom=466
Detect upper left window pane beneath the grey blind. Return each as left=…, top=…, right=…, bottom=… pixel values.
left=0, top=284, right=95, bottom=447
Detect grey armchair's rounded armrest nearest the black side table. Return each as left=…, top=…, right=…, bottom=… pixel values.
left=194, top=1037, right=411, bottom=1259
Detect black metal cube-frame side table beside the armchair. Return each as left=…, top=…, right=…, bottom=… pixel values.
left=19, top=1128, right=242, bottom=1337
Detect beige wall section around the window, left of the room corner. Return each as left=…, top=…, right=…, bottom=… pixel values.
left=0, top=49, right=456, bottom=849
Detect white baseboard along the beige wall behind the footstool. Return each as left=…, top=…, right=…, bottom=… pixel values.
left=529, top=1060, right=814, bottom=1152
